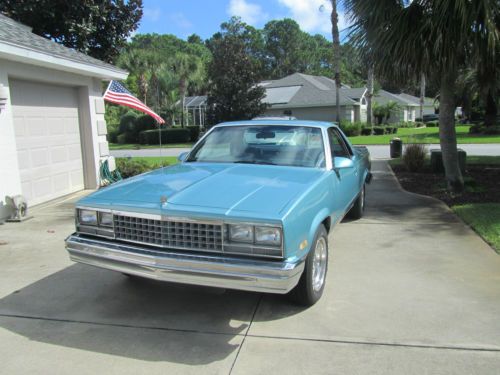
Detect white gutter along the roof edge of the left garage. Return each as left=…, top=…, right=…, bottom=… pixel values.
left=0, top=41, right=128, bottom=80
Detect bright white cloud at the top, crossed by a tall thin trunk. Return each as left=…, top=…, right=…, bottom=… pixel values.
left=278, top=0, right=348, bottom=34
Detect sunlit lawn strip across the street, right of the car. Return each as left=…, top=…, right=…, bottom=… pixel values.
left=349, top=126, right=500, bottom=145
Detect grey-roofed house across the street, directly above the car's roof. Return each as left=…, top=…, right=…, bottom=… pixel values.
left=260, top=73, right=366, bottom=121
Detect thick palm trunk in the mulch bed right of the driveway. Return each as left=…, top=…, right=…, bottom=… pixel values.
left=439, top=72, right=464, bottom=193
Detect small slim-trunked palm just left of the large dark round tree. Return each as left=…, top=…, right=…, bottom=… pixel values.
left=172, top=52, right=204, bottom=127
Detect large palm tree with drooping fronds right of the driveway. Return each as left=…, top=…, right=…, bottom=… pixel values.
left=344, top=0, right=500, bottom=192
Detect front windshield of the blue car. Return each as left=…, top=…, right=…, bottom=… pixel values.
left=186, top=125, right=325, bottom=168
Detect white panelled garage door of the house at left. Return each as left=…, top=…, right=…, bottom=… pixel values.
left=9, top=80, right=83, bottom=205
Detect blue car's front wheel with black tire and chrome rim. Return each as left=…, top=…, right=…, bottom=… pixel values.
left=289, top=224, right=328, bottom=306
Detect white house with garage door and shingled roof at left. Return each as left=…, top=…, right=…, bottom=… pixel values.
left=0, top=15, right=127, bottom=219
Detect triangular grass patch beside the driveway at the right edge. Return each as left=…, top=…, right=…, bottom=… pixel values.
left=452, top=203, right=500, bottom=253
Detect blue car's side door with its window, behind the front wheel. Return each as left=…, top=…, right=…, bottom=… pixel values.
left=328, top=127, right=359, bottom=211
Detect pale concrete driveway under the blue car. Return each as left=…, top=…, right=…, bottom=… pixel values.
left=0, top=161, right=500, bottom=375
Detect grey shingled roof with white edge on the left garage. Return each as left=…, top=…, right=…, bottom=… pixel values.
left=0, top=13, right=128, bottom=79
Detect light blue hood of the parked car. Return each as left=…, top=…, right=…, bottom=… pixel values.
left=80, top=163, right=324, bottom=214
